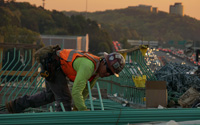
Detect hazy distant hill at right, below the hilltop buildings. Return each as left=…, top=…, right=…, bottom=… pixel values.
left=64, top=8, right=200, bottom=47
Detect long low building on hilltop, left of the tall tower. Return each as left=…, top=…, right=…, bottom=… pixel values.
left=128, top=4, right=158, bottom=13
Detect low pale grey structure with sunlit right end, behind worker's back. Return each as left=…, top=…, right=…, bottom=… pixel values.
left=41, top=34, right=89, bottom=52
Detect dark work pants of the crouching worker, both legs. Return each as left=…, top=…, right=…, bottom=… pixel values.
left=13, top=68, right=72, bottom=112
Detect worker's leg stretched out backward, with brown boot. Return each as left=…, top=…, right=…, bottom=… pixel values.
left=6, top=82, right=55, bottom=113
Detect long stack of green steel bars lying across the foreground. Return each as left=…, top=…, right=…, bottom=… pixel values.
left=0, top=109, right=200, bottom=125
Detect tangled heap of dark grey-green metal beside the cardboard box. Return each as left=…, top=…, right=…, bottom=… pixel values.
left=155, top=63, right=200, bottom=98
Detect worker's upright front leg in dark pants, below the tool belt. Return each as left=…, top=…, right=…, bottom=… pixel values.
left=46, top=69, right=72, bottom=111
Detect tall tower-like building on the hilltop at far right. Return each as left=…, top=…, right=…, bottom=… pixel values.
left=169, top=3, right=184, bottom=16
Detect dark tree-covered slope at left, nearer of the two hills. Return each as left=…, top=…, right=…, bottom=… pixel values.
left=0, top=0, right=112, bottom=54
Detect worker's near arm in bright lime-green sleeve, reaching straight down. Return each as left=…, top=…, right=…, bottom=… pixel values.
left=72, top=57, right=94, bottom=111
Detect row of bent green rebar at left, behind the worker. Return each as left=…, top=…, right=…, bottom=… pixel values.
left=0, top=48, right=44, bottom=105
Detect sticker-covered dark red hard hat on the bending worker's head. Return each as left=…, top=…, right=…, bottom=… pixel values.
left=104, top=52, right=125, bottom=77
